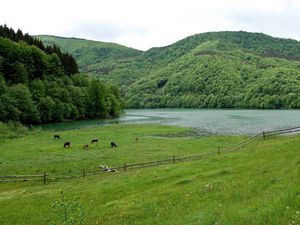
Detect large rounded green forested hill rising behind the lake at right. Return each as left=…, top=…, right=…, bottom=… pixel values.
left=37, top=31, right=300, bottom=108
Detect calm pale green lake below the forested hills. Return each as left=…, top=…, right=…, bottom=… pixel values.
left=39, top=109, right=300, bottom=134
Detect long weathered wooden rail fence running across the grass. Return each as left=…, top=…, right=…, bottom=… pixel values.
left=0, top=127, right=300, bottom=184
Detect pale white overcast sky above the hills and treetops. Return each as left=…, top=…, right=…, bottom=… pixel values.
left=0, top=0, right=300, bottom=50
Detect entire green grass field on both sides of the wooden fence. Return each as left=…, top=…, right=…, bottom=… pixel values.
left=0, top=125, right=300, bottom=225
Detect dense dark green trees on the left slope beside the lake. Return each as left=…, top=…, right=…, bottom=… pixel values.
left=0, top=26, right=121, bottom=124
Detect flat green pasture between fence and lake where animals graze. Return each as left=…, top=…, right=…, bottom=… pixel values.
left=0, top=125, right=241, bottom=174
